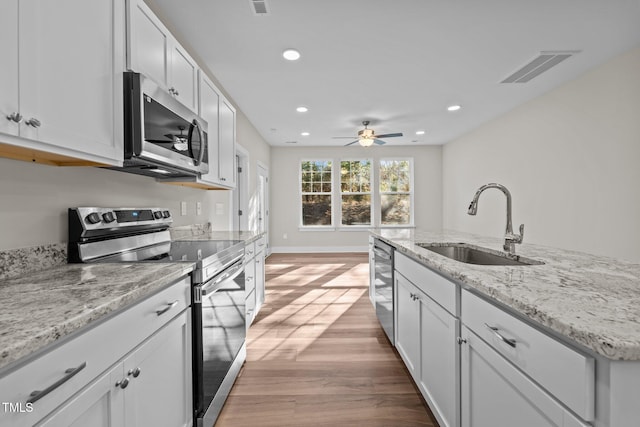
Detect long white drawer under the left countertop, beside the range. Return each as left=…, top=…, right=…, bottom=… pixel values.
left=0, top=277, right=190, bottom=427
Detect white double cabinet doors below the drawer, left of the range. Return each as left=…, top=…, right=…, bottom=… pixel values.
left=36, top=310, right=193, bottom=427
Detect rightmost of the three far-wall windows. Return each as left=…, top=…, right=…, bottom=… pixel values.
left=379, top=159, right=412, bottom=225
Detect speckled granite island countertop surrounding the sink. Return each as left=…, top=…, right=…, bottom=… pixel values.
left=372, top=229, right=640, bottom=361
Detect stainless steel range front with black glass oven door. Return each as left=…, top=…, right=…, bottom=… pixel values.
left=192, top=258, right=246, bottom=425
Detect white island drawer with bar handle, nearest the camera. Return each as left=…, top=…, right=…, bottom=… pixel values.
left=461, top=290, right=595, bottom=421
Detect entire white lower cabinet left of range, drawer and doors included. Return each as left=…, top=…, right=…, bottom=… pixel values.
left=0, top=277, right=193, bottom=427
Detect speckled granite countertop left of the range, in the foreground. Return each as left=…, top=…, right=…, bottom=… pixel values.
left=0, top=263, right=194, bottom=370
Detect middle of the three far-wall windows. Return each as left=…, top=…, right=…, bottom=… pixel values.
left=340, top=160, right=371, bottom=226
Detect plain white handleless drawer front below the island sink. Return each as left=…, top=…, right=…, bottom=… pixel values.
left=394, top=251, right=457, bottom=315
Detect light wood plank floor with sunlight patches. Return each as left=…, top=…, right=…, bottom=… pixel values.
left=216, top=254, right=438, bottom=427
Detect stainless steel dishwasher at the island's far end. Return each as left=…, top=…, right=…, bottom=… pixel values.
left=373, top=239, right=395, bottom=345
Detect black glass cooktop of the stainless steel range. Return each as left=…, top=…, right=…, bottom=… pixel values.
left=96, top=240, right=242, bottom=262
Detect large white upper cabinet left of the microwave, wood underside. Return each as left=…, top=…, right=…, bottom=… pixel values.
left=0, top=0, right=124, bottom=165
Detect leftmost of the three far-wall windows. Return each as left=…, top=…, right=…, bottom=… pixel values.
left=300, top=160, right=332, bottom=226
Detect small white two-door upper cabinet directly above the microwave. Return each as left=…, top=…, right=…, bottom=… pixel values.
left=127, top=0, right=198, bottom=111
